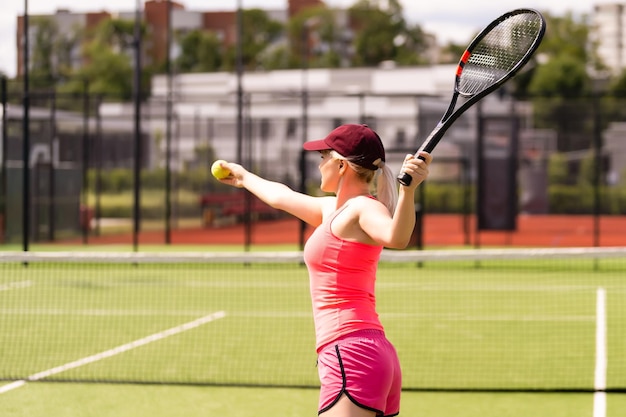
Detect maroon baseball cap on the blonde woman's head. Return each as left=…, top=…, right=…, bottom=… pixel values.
left=304, top=124, right=385, bottom=171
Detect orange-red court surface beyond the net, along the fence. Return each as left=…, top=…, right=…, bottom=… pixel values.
left=74, top=214, right=626, bottom=249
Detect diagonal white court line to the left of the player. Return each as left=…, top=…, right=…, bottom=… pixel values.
left=0, top=311, right=226, bottom=394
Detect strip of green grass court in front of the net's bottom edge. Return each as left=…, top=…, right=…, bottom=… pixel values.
left=0, top=383, right=626, bottom=417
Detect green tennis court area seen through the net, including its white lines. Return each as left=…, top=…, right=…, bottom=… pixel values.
left=0, top=251, right=626, bottom=415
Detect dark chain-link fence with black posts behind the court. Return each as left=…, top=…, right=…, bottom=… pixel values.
left=0, top=76, right=626, bottom=243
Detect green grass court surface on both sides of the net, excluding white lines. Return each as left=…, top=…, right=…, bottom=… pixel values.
left=0, top=255, right=626, bottom=417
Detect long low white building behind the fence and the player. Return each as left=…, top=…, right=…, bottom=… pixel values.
left=140, top=64, right=540, bottom=185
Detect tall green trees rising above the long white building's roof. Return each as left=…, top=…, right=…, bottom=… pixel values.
left=15, top=0, right=608, bottom=96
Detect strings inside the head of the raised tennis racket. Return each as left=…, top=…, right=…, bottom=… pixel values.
left=458, top=13, right=543, bottom=96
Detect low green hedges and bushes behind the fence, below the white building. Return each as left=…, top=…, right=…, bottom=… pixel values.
left=88, top=169, right=626, bottom=218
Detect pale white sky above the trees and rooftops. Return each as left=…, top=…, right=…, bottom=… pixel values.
left=0, top=0, right=600, bottom=77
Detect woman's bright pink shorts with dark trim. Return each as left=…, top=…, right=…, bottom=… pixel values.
left=317, top=330, right=402, bottom=416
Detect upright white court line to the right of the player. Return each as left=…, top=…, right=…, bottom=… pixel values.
left=593, top=288, right=607, bottom=417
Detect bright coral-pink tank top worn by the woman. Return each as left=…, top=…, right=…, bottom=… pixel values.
left=304, top=202, right=383, bottom=352
